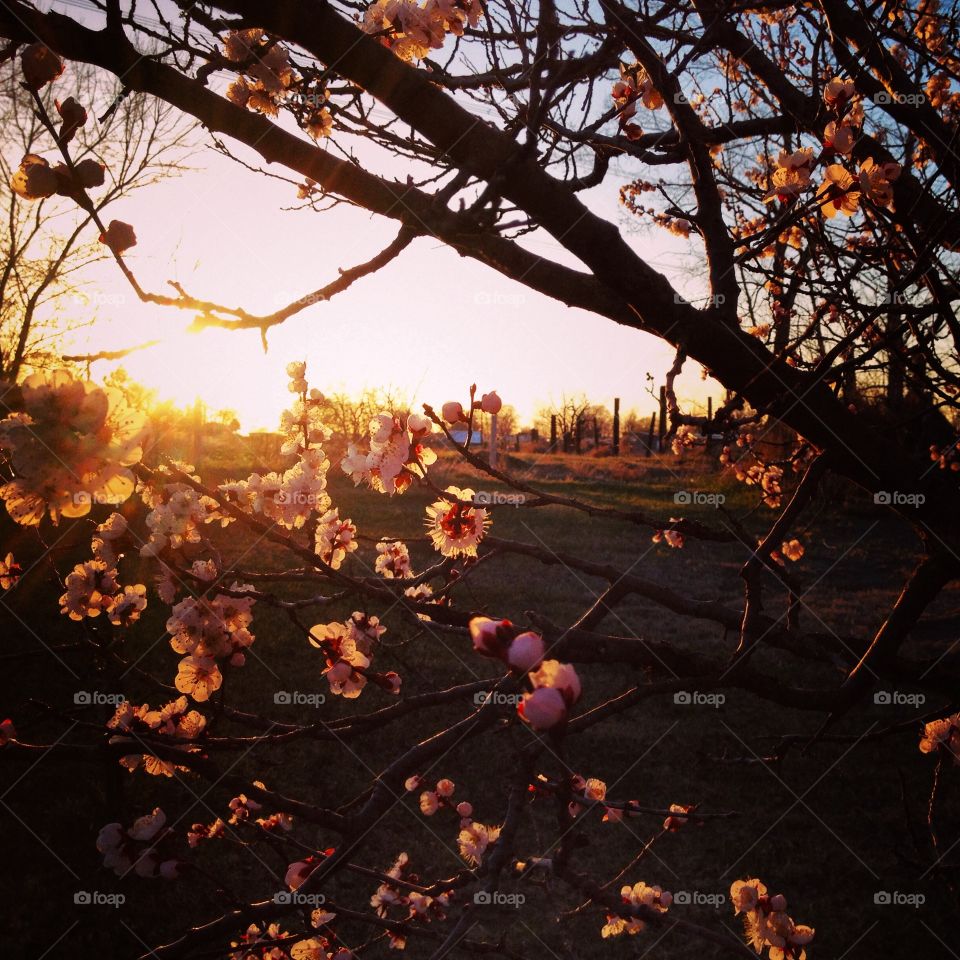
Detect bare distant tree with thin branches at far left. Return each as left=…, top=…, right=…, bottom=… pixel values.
left=0, top=61, right=196, bottom=380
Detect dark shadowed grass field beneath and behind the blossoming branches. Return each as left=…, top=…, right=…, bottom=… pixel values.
left=0, top=457, right=960, bottom=960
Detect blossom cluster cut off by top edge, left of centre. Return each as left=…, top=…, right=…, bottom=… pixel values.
left=361, top=0, right=483, bottom=60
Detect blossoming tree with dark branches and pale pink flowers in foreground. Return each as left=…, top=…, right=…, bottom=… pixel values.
left=0, top=0, right=960, bottom=960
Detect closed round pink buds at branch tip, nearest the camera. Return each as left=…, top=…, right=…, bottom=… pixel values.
left=470, top=617, right=581, bottom=730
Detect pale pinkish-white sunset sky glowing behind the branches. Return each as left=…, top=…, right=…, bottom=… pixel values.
left=43, top=2, right=720, bottom=430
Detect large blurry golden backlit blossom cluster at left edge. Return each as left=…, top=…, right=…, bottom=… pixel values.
left=0, top=370, right=144, bottom=526
